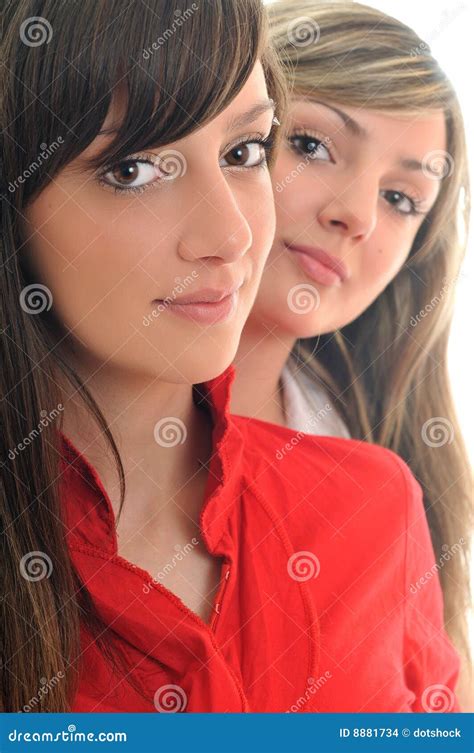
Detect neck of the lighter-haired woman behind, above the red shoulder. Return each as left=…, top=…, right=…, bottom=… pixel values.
left=231, top=321, right=295, bottom=426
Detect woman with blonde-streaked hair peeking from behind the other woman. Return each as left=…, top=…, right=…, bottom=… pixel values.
left=232, top=0, right=473, bottom=697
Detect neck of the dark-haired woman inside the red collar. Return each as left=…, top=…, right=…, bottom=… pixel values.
left=57, top=346, right=212, bottom=514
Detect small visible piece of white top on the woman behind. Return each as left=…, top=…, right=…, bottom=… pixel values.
left=281, top=363, right=350, bottom=439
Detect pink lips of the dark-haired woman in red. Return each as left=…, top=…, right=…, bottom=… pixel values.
left=155, top=285, right=241, bottom=324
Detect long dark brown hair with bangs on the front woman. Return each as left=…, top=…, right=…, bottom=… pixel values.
left=0, top=0, right=286, bottom=712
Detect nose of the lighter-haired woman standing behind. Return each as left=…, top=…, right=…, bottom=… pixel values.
left=318, top=179, right=379, bottom=242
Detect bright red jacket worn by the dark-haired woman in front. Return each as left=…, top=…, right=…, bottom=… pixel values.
left=61, top=367, right=460, bottom=712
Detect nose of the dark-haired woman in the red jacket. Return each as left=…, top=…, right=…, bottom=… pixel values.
left=178, top=169, right=253, bottom=264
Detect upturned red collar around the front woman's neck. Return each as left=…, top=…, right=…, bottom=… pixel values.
left=60, top=366, right=243, bottom=554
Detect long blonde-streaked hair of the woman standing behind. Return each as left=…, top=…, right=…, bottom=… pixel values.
left=269, top=0, right=473, bottom=666
